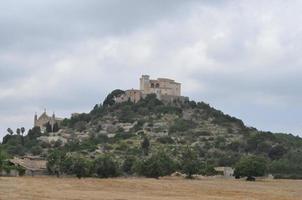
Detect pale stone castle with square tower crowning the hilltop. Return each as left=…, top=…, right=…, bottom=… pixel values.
left=115, top=75, right=188, bottom=103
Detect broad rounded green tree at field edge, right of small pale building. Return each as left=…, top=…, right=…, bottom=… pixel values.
left=234, top=156, right=267, bottom=180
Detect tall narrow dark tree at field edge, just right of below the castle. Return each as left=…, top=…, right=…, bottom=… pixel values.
left=181, top=147, right=201, bottom=178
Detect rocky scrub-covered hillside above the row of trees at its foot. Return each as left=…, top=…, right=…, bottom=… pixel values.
left=1, top=90, right=302, bottom=177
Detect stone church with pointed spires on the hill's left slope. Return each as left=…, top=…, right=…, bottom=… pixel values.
left=34, top=110, right=63, bottom=132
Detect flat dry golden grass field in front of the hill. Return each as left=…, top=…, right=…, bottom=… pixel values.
left=0, top=177, right=302, bottom=200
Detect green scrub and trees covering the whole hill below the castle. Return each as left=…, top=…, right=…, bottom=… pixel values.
left=0, top=90, right=302, bottom=178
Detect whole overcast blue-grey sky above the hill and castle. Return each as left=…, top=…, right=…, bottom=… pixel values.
left=0, top=0, right=302, bottom=137
